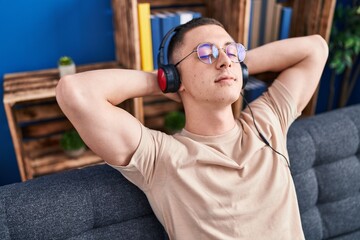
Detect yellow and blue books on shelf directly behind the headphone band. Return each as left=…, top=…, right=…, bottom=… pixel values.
left=138, top=3, right=201, bottom=71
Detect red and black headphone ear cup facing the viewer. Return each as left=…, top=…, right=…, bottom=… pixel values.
left=158, top=64, right=181, bottom=93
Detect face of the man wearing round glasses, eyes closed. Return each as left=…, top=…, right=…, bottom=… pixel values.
left=174, top=25, right=242, bottom=106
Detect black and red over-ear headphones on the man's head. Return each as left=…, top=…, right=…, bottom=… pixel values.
left=157, top=25, right=249, bottom=93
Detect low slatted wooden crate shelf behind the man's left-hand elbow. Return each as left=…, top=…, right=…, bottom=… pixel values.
left=4, top=62, right=142, bottom=181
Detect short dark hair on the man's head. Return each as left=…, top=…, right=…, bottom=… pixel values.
left=167, top=17, right=224, bottom=62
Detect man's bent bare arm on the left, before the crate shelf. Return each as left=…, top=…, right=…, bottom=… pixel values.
left=56, top=69, right=161, bottom=166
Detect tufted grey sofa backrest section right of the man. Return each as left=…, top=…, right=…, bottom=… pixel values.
left=287, top=105, right=360, bottom=240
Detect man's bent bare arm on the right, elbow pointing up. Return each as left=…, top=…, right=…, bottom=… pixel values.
left=245, top=35, right=328, bottom=112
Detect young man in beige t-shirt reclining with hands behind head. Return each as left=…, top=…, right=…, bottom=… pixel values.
left=56, top=18, right=328, bottom=240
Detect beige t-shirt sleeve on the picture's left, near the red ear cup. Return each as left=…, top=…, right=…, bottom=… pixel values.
left=109, top=124, right=165, bottom=191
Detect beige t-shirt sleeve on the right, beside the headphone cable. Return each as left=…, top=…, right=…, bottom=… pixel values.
left=244, top=80, right=300, bottom=137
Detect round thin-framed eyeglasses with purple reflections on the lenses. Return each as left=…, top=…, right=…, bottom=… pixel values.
left=175, top=43, right=246, bottom=67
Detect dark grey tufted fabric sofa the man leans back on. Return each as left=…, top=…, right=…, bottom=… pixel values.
left=0, top=105, right=360, bottom=240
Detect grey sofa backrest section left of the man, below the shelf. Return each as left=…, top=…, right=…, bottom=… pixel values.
left=0, top=165, right=164, bottom=240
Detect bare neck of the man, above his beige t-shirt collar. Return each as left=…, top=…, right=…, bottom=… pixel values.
left=185, top=106, right=236, bottom=136
